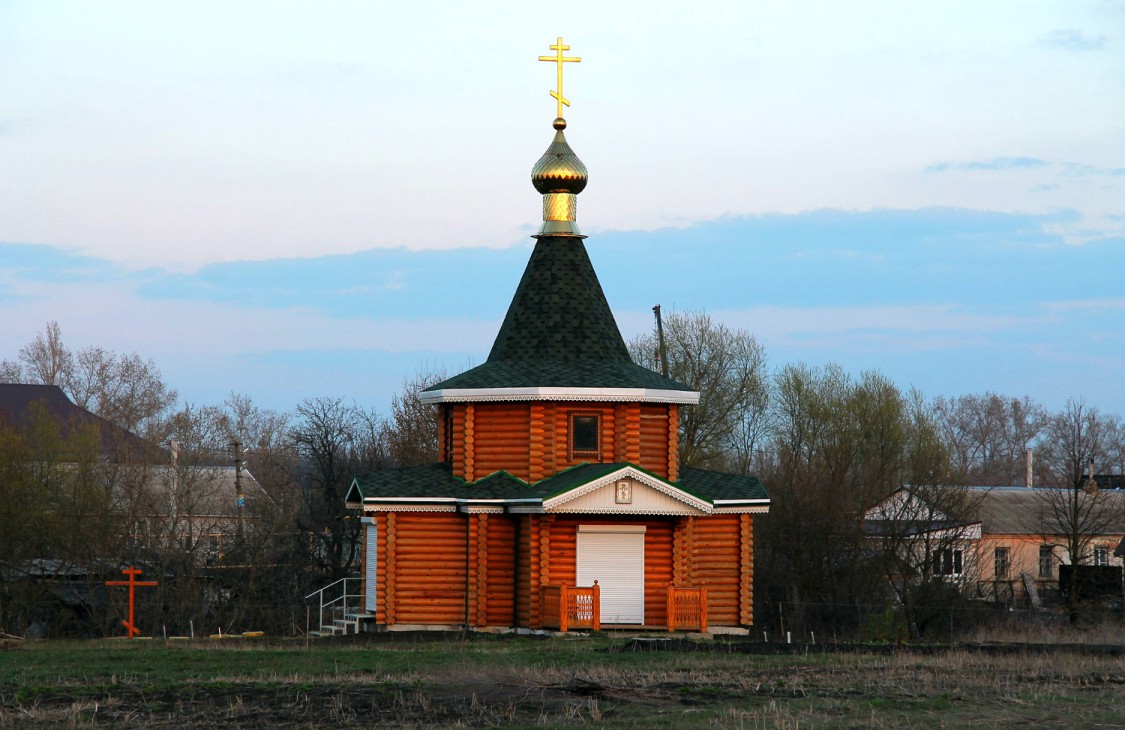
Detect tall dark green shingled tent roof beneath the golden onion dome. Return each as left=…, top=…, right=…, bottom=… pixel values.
left=424, top=236, right=692, bottom=391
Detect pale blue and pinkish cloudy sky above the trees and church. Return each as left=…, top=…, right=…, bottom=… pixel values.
left=0, top=0, right=1125, bottom=416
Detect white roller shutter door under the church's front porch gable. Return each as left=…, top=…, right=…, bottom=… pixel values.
left=576, top=525, right=645, bottom=624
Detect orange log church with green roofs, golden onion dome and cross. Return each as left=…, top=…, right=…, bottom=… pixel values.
left=337, top=38, right=770, bottom=632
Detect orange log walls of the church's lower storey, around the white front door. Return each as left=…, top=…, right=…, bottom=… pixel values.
left=376, top=512, right=754, bottom=628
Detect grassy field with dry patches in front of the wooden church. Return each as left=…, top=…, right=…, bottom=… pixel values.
left=0, top=634, right=1125, bottom=728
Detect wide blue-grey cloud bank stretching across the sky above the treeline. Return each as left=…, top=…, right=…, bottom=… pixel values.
left=0, top=208, right=1125, bottom=412
